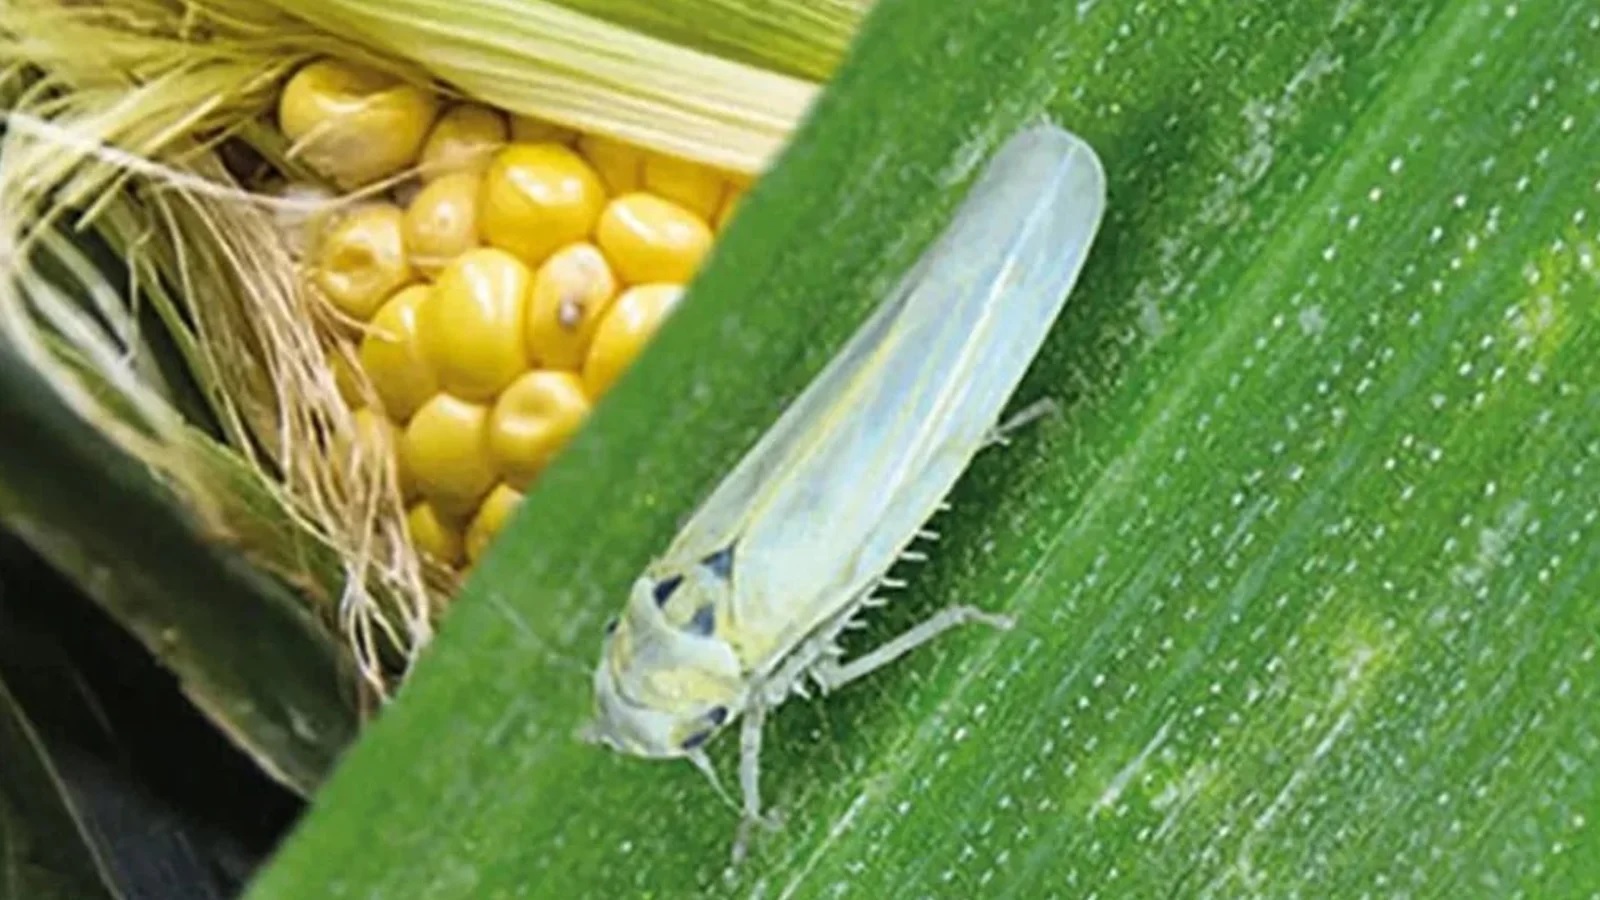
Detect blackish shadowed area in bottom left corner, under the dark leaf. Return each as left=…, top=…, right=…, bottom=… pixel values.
left=0, top=530, right=301, bottom=900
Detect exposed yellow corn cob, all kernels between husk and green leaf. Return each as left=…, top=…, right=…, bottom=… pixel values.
left=278, top=59, right=747, bottom=567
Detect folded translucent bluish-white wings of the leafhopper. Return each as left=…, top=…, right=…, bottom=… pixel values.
left=675, top=125, right=1106, bottom=668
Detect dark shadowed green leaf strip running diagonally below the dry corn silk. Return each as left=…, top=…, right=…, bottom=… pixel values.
left=0, top=343, right=357, bottom=793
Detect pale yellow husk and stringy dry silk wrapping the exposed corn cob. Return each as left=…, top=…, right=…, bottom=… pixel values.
left=0, top=0, right=851, bottom=720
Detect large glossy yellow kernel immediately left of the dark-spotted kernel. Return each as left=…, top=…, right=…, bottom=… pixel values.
left=418, top=247, right=533, bottom=400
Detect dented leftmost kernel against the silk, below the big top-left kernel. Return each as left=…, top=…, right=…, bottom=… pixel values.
left=312, top=203, right=416, bottom=322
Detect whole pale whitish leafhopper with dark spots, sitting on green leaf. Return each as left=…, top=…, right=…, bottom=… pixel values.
left=584, top=123, right=1106, bottom=855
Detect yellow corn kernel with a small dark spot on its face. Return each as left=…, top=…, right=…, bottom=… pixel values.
left=528, top=243, right=618, bottom=372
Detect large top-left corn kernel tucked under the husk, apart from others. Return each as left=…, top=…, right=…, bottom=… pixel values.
left=278, top=59, right=438, bottom=191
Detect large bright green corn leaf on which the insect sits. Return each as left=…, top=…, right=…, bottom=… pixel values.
left=251, top=0, right=1600, bottom=900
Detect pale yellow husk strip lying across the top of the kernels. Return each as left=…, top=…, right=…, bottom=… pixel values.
left=266, top=0, right=816, bottom=175
